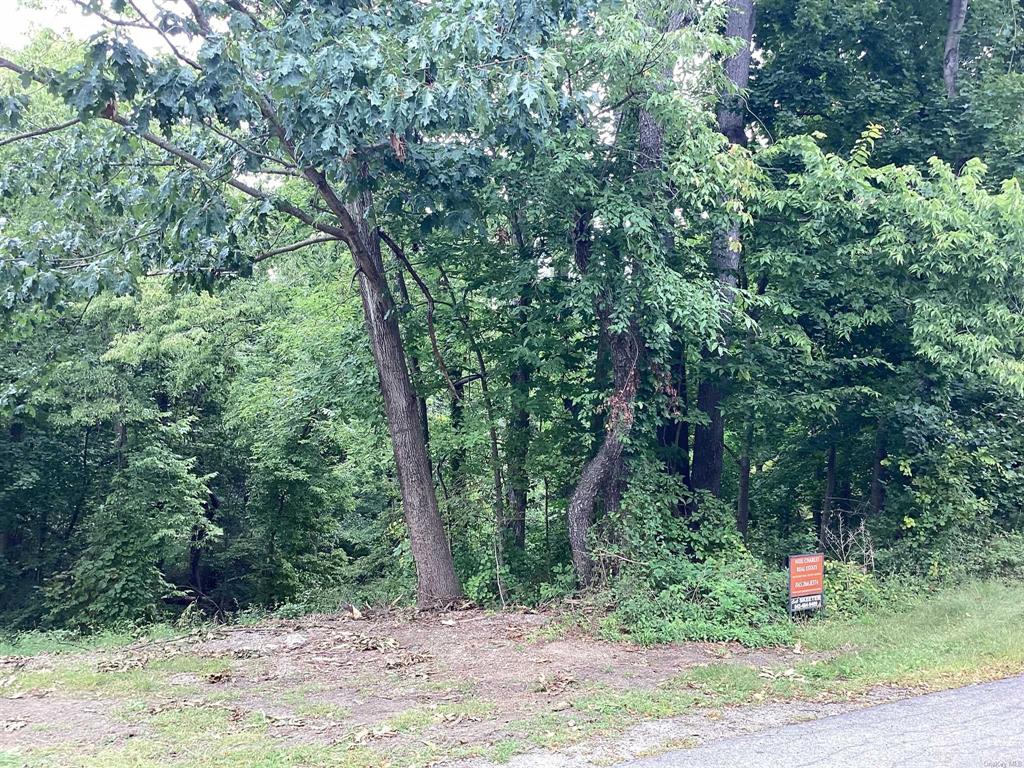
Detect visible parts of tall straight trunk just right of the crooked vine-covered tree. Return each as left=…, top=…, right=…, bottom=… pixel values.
left=691, top=0, right=754, bottom=497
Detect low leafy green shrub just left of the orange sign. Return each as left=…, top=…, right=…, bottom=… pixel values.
left=603, top=555, right=793, bottom=646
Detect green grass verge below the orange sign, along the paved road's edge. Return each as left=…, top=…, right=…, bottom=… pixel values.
left=519, top=582, right=1024, bottom=749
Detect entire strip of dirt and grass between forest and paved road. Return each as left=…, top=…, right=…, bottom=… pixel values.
left=0, top=583, right=1024, bottom=768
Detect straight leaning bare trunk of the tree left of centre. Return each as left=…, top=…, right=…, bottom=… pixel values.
left=349, top=198, right=462, bottom=608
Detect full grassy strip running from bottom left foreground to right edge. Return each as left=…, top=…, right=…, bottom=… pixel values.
left=0, top=582, right=1024, bottom=768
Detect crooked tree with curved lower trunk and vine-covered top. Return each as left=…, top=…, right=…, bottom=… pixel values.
left=552, top=3, right=737, bottom=586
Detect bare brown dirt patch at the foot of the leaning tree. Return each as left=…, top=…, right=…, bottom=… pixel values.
left=190, top=610, right=787, bottom=701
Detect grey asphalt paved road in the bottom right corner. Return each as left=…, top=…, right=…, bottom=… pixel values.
left=621, top=677, right=1024, bottom=768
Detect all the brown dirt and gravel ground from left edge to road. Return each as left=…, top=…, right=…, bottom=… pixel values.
left=0, top=609, right=903, bottom=768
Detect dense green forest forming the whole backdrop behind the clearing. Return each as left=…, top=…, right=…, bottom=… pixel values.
left=0, top=0, right=1024, bottom=641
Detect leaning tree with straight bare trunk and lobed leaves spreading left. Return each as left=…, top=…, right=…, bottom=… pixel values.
left=0, top=2, right=557, bottom=606
